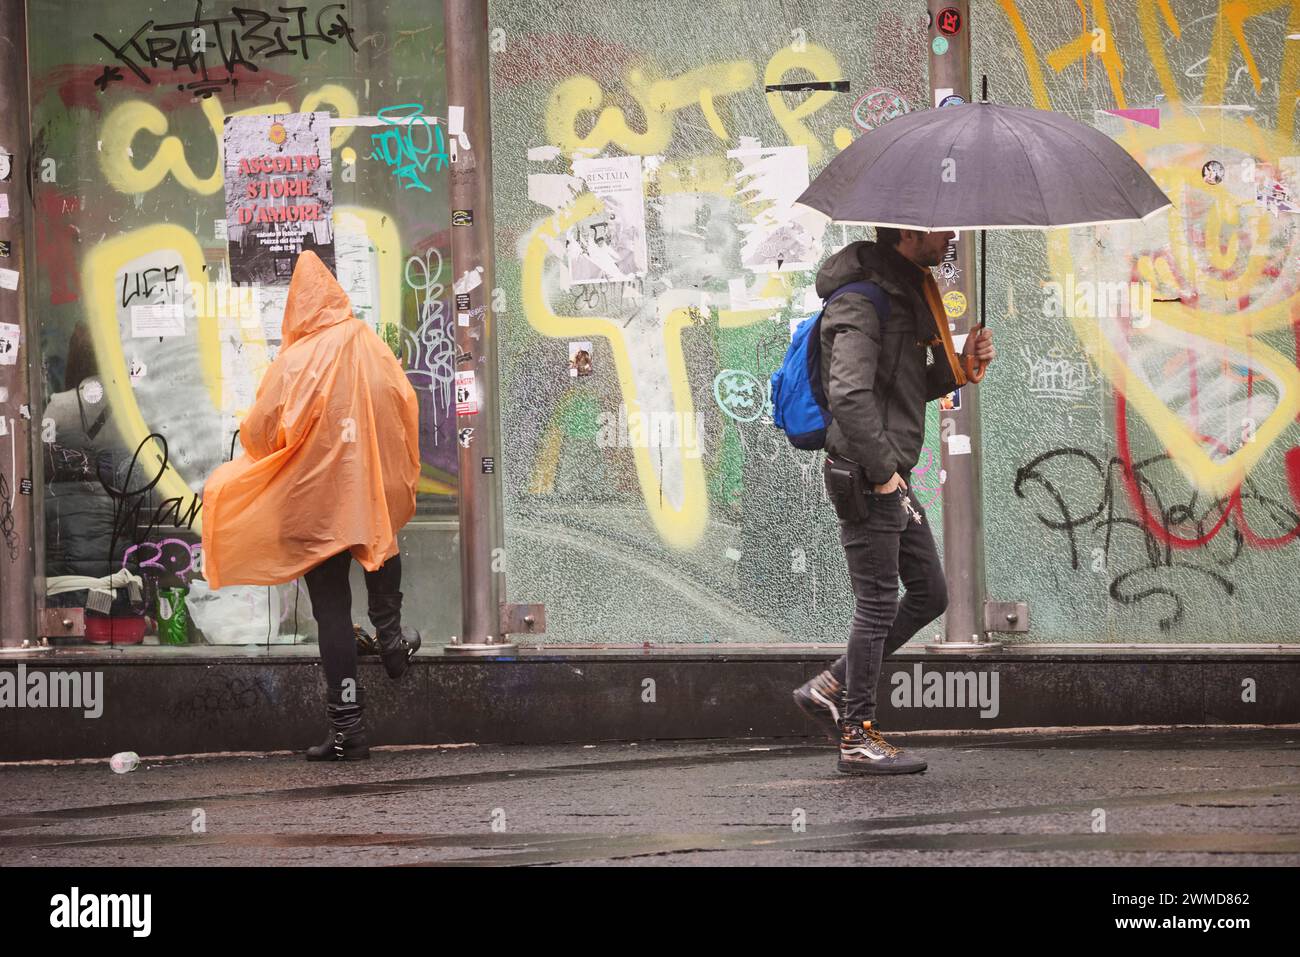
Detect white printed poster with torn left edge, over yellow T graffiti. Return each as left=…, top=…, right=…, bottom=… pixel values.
left=569, top=156, right=650, bottom=283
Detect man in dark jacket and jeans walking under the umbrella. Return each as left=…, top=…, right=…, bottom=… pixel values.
left=794, top=228, right=995, bottom=774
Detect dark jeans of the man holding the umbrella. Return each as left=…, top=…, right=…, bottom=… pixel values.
left=831, top=475, right=948, bottom=722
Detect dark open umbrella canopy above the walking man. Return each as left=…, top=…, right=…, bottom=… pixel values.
left=796, top=103, right=1171, bottom=230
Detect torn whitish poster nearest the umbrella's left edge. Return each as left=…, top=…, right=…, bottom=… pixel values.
left=727, top=146, right=826, bottom=273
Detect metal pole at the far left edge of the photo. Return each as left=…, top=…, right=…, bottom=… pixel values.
left=0, top=0, right=44, bottom=649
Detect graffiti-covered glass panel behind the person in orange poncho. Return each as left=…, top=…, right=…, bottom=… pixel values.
left=29, top=0, right=459, bottom=644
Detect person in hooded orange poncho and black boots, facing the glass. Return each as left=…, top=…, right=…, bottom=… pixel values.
left=203, top=251, right=420, bottom=761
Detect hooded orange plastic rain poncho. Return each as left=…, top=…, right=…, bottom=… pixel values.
left=203, top=251, right=420, bottom=588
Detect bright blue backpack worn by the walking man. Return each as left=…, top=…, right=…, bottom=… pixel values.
left=772, top=280, right=889, bottom=451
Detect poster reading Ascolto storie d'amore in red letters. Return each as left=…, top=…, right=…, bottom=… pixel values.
left=224, top=113, right=334, bottom=286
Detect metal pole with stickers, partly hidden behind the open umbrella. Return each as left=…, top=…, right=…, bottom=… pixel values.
left=926, top=0, right=997, bottom=651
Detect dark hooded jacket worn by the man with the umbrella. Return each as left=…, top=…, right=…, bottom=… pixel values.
left=816, top=242, right=957, bottom=485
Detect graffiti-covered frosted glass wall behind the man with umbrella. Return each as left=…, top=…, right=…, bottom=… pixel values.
left=490, top=0, right=1300, bottom=642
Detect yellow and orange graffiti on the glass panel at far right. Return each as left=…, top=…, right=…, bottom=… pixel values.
left=1000, top=0, right=1300, bottom=495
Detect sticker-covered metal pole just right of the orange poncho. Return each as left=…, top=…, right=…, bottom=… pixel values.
left=442, top=0, right=515, bottom=655
